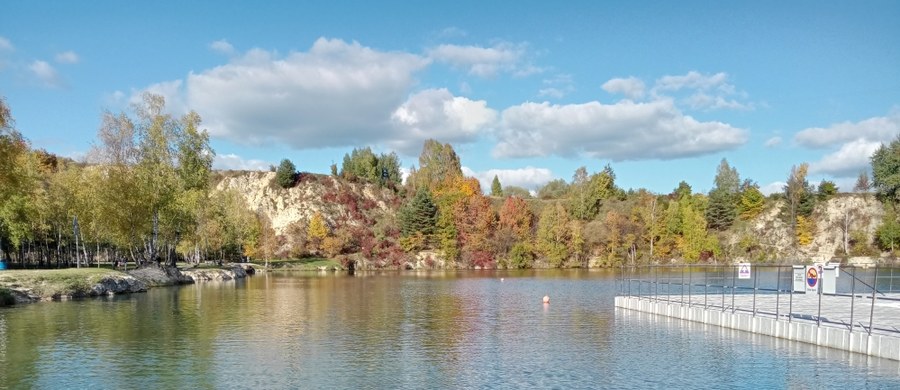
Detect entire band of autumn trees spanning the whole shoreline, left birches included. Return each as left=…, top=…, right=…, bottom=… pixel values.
left=0, top=94, right=900, bottom=268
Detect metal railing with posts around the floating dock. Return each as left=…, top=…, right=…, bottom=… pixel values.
left=618, top=264, right=900, bottom=337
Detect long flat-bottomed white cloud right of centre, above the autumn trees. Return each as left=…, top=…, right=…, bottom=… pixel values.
left=493, top=99, right=747, bottom=161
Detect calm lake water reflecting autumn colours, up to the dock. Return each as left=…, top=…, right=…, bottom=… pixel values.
left=0, top=271, right=900, bottom=389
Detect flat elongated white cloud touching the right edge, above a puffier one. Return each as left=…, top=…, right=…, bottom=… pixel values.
left=794, top=113, right=900, bottom=148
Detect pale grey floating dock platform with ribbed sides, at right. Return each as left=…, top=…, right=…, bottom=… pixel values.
left=616, top=293, right=900, bottom=361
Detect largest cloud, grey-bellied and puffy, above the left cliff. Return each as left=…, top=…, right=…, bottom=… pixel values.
left=135, top=38, right=432, bottom=149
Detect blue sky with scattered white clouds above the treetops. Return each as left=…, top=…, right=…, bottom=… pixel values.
left=0, top=1, right=900, bottom=193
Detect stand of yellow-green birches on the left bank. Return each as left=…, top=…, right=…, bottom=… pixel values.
left=0, top=94, right=263, bottom=267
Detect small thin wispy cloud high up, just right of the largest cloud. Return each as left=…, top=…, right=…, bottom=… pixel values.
left=427, top=43, right=542, bottom=77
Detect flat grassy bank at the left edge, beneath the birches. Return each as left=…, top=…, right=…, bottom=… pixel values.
left=0, top=268, right=123, bottom=300
